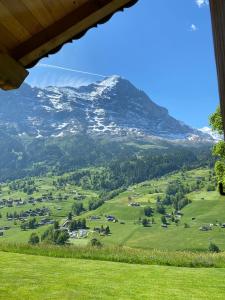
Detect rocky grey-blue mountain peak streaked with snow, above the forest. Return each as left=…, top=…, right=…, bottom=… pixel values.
left=0, top=76, right=211, bottom=141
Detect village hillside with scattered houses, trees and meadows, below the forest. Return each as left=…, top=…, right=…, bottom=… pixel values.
left=0, top=169, right=225, bottom=248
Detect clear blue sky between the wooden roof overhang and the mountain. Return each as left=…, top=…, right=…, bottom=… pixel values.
left=27, top=0, right=219, bottom=128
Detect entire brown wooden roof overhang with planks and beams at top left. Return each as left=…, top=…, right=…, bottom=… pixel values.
left=0, top=0, right=138, bottom=90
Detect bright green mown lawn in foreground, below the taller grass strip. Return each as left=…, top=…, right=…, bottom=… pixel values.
left=0, top=252, right=225, bottom=300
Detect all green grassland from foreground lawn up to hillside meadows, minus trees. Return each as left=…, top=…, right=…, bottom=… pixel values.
left=0, top=164, right=225, bottom=300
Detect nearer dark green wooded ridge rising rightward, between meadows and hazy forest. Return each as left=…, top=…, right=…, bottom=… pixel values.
left=55, top=147, right=213, bottom=191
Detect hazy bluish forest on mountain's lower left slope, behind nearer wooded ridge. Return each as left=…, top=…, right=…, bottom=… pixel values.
left=0, top=130, right=137, bottom=181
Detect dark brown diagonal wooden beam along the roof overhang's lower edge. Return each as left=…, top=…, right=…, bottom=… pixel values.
left=10, top=0, right=135, bottom=67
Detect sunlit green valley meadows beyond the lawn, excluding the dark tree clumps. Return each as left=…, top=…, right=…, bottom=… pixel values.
left=0, top=168, right=225, bottom=251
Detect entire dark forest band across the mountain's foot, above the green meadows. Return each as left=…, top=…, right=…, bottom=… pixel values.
left=0, top=127, right=213, bottom=183
